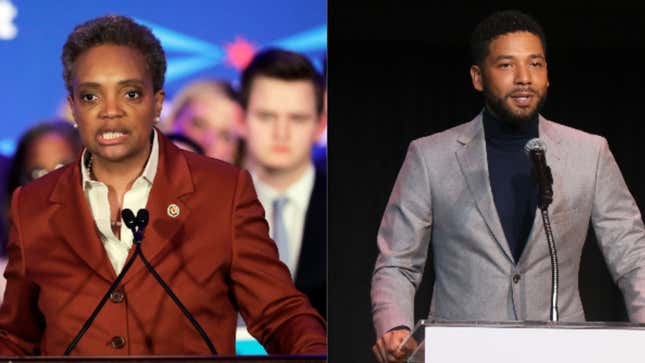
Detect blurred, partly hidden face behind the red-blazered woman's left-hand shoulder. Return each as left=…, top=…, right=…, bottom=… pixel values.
left=25, top=132, right=76, bottom=180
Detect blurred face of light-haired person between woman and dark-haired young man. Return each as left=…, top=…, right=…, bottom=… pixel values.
left=173, top=93, right=242, bottom=163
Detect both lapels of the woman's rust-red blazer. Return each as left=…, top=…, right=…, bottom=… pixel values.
left=49, top=130, right=194, bottom=284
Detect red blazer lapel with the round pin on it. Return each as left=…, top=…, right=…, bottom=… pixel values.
left=123, top=131, right=194, bottom=284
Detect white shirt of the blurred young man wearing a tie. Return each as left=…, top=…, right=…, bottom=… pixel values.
left=251, top=163, right=316, bottom=278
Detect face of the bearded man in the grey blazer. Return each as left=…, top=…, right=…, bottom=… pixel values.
left=470, top=31, right=549, bottom=123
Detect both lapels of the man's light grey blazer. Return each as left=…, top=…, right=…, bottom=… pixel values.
left=455, top=113, right=561, bottom=262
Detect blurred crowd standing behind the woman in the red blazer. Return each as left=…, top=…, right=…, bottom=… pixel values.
left=0, top=49, right=327, bottom=317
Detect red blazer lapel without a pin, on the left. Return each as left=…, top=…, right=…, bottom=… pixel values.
left=50, top=158, right=116, bottom=281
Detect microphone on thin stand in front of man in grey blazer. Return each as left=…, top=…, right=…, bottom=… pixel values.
left=524, top=138, right=560, bottom=322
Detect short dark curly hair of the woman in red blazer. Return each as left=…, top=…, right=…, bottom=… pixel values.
left=61, top=15, right=166, bottom=94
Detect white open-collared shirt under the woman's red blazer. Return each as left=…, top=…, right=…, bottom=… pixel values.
left=81, top=129, right=159, bottom=275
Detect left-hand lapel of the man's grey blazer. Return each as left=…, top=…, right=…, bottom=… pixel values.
left=455, top=113, right=513, bottom=262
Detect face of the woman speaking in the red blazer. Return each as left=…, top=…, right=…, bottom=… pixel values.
left=68, top=44, right=164, bottom=166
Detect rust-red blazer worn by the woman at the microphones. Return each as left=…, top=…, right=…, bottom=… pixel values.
left=0, top=132, right=326, bottom=355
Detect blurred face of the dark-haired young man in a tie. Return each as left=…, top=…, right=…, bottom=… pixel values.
left=243, top=76, right=322, bottom=171
